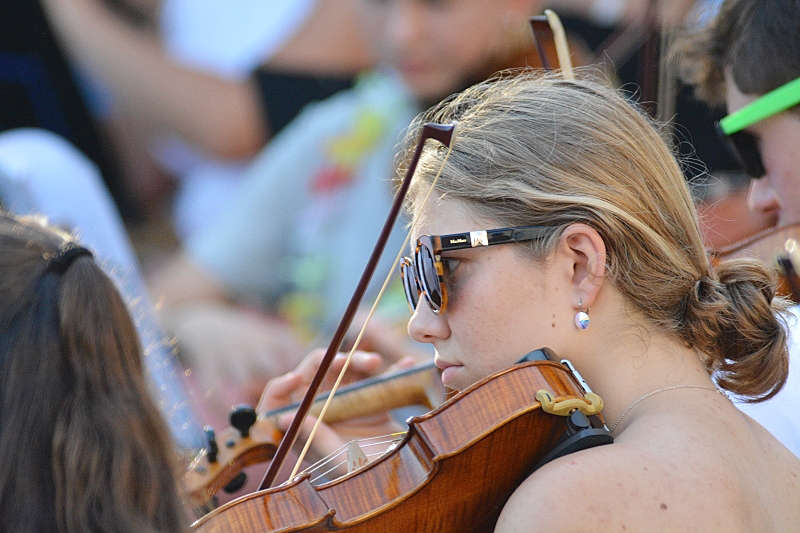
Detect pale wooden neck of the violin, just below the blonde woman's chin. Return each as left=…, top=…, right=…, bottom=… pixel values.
left=263, top=363, right=438, bottom=422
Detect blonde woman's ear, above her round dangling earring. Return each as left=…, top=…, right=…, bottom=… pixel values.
left=557, top=223, right=606, bottom=310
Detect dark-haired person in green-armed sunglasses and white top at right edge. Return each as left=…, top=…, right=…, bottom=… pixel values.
left=677, top=0, right=800, bottom=456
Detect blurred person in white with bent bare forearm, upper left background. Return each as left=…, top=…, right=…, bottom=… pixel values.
left=42, top=0, right=372, bottom=237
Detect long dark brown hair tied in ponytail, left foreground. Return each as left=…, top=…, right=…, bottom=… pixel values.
left=0, top=212, right=186, bottom=532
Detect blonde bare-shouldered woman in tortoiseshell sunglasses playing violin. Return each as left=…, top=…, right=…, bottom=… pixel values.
left=262, top=71, right=800, bottom=533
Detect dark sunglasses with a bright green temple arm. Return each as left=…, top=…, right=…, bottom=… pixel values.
left=717, top=78, right=800, bottom=178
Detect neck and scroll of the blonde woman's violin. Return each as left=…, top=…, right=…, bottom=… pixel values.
left=183, top=363, right=442, bottom=506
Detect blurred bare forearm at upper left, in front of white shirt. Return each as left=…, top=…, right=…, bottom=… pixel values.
left=42, top=0, right=267, bottom=157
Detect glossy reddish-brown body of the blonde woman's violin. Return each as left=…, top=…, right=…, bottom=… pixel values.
left=193, top=361, right=610, bottom=533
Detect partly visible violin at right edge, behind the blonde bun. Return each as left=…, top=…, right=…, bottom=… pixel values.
left=709, top=223, right=800, bottom=302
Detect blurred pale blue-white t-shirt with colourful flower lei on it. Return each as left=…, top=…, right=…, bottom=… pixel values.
left=186, top=73, right=416, bottom=334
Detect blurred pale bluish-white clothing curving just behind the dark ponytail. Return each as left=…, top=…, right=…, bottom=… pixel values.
left=0, top=128, right=204, bottom=448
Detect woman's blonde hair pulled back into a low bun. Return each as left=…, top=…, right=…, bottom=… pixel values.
left=398, top=72, right=788, bottom=401
